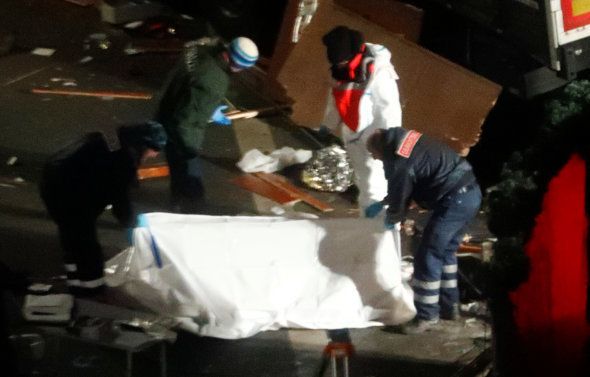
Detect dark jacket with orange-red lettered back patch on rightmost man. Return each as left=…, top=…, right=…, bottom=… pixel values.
left=383, top=127, right=475, bottom=223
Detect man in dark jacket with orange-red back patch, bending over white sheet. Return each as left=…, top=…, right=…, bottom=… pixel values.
left=367, top=128, right=481, bottom=334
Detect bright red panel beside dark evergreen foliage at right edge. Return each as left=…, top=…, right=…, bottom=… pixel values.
left=511, top=155, right=590, bottom=377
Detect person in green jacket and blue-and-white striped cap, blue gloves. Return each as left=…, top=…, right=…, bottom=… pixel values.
left=156, top=37, right=258, bottom=213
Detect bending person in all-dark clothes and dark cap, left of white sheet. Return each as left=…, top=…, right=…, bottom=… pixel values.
left=39, top=122, right=166, bottom=295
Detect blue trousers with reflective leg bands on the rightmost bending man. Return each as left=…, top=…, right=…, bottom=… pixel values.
left=412, top=183, right=481, bottom=320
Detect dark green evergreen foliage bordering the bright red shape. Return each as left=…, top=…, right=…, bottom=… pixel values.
left=487, top=80, right=590, bottom=292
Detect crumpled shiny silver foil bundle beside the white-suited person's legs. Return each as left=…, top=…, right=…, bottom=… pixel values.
left=301, top=145, right=353, bottom=192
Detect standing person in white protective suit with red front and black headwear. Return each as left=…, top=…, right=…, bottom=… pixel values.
left=322, top=26, right=402, bottom=212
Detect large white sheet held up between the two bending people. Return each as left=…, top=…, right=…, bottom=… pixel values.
left=107, top=213, right=416, bottom=339
